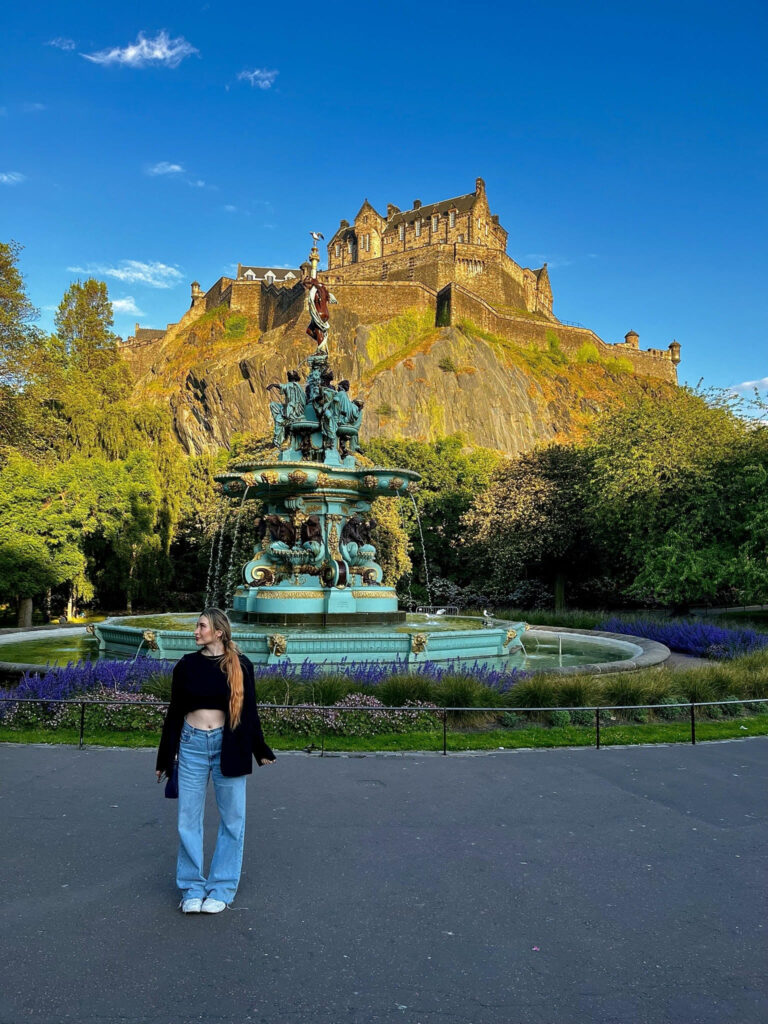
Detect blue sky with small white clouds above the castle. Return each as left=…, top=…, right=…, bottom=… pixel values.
left=0, top=0, right=768, bottom=388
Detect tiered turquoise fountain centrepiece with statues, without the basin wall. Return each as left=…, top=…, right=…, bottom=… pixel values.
left=216, top=234, right=420, bottom=625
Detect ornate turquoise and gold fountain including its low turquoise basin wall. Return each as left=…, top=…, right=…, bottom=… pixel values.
left=95, top=240, right=525, bottom=668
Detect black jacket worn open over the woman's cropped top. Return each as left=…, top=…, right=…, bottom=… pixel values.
left=157, top=653, right=274, bottom=776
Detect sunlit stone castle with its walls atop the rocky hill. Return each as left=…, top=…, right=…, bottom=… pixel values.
left=125, top=178, right=680, bottom=383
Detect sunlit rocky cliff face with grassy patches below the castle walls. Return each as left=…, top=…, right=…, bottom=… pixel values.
left=126, top=307, right=671, bottom=454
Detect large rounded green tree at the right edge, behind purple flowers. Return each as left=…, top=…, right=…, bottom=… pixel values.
left=586, top=388, right=768, bottom=611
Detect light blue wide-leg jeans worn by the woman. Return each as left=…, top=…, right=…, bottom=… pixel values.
left=176, top=722, right=246, bottom=903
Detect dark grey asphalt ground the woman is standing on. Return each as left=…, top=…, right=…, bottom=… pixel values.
left=0, top=738, right=768, bottom=1024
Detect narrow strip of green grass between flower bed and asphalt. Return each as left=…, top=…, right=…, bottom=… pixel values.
left=0, top=715, right=768, bottom=753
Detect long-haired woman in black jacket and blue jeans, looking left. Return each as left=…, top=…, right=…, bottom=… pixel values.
left=157, top=608, right=274, bottom=913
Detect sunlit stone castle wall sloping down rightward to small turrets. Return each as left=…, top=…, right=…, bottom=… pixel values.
left=437, top=284, right=677, bottom=384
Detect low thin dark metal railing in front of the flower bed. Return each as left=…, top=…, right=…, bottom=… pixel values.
left=0, top=696, right=768, bottom=756
